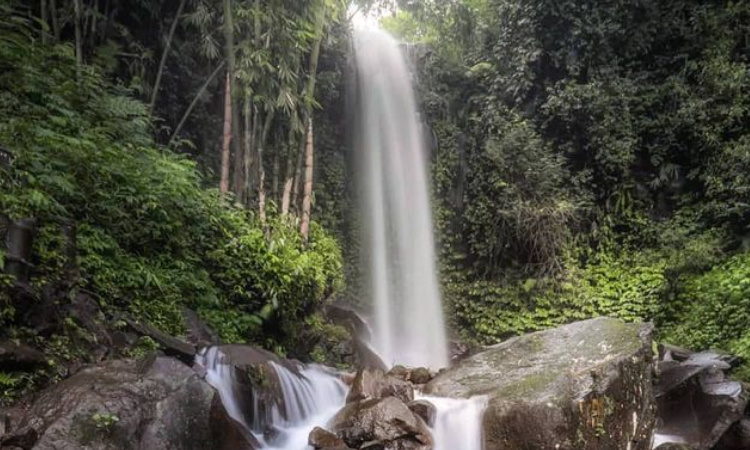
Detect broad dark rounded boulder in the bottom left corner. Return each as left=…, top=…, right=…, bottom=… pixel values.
left=0, top=357, right=254, bottom=450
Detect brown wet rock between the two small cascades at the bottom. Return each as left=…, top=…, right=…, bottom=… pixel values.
left=331, top=397, right=432, bottom=450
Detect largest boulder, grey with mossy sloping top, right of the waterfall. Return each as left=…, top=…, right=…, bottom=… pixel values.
left=425, top=318, right=655, bottom=450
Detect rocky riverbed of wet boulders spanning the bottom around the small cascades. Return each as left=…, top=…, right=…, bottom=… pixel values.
left=0, top=318, right=750, bottom=450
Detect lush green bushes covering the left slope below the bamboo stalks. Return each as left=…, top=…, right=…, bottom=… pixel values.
left=0, top=19, right=341, bottom=354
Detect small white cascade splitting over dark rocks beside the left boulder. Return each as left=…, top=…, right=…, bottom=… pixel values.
left=198, top=347, right=348, bottom=450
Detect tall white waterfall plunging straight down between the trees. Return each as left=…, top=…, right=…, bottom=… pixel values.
left=354, top=28, right=448, bottom=369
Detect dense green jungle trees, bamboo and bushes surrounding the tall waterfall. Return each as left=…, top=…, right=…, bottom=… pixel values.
left=0, top=0, right=750, bottom=401
